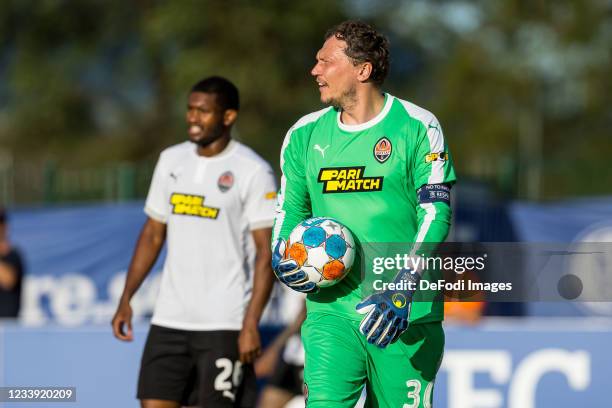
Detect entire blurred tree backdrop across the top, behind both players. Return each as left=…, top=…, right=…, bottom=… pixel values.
left=0, top=0, right=612, bottom=199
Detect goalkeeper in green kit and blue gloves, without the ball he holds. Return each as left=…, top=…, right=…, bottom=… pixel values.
left=273, top=21, right=455, bottom=408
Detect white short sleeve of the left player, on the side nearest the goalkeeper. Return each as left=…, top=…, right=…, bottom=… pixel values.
left=244, top=163, right=276, bottom=231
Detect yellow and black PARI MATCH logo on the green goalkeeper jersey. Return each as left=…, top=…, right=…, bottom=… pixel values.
left=317, top=166, right=384, bottom=194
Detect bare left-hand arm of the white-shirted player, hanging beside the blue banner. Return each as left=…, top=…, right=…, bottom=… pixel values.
left=112, top=218, right=166, bottom=341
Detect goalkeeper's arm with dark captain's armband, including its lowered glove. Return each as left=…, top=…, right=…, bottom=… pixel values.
left=357, top=116, right=455, bottom=347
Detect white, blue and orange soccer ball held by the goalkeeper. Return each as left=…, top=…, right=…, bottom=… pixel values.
left=285, top=217, right=355, bottom=288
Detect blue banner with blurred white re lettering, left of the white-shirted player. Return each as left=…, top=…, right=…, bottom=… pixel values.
left=10, top=202, right=164, bottom=326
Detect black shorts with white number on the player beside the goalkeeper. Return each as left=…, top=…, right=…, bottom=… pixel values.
left=137, top=325, right=257, bottom=408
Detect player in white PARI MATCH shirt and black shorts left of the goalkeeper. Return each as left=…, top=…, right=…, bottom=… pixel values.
left=112, top=77, right=276, bottom=408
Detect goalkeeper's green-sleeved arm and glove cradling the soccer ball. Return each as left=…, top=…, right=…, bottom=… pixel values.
left=272, top=127, right=317, bottom=292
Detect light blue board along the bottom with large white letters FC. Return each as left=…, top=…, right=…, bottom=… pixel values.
left=0, top=318, right=612, bottom=408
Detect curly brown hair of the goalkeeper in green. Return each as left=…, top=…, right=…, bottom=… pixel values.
left=325, top=20, right=389, bottom=85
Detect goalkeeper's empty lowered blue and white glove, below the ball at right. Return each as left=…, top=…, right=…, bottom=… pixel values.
left=356, top=269, right=420, bottom=348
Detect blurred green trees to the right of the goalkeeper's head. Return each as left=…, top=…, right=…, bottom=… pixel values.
left=353, top=0, right=612, bottom=199
